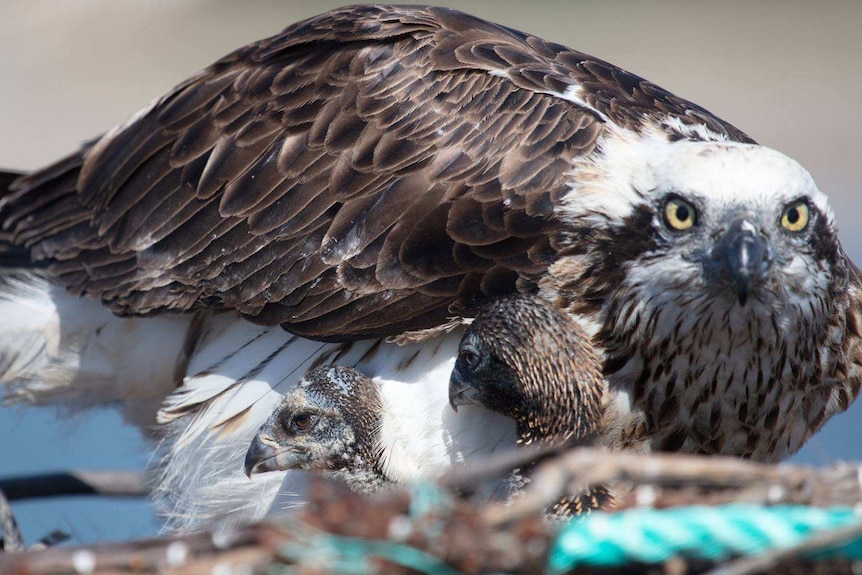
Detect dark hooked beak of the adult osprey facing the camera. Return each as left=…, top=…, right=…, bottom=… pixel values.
left=708, top=218, right=772, bottom=306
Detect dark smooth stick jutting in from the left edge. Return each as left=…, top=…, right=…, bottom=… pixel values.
left=0, top=471, right=149, bottom=501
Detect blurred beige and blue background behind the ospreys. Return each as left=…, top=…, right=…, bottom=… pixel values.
left=0, top=0, right=862, bottom=543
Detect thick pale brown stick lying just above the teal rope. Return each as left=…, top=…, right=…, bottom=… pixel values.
left=487, top=448, right=862, bottom=524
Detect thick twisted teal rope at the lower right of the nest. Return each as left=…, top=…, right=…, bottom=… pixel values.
left=548, top=504, right=862, bottom=572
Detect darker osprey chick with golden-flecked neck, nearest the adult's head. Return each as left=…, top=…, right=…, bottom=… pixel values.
left=449, top=297, right=613, bottom=515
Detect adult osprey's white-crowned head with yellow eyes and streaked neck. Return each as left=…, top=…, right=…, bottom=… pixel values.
left=542, top=141, right=859, bottom=460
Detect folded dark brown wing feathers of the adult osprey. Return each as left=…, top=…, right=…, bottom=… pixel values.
left=0, top=6, right=744, bottom=340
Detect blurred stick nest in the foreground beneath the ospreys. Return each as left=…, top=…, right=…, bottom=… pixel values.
left=0, top=447, right=862, bottom=575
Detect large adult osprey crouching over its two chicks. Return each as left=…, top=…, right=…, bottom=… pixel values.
left=0, top=5, right=862, bottom=528
